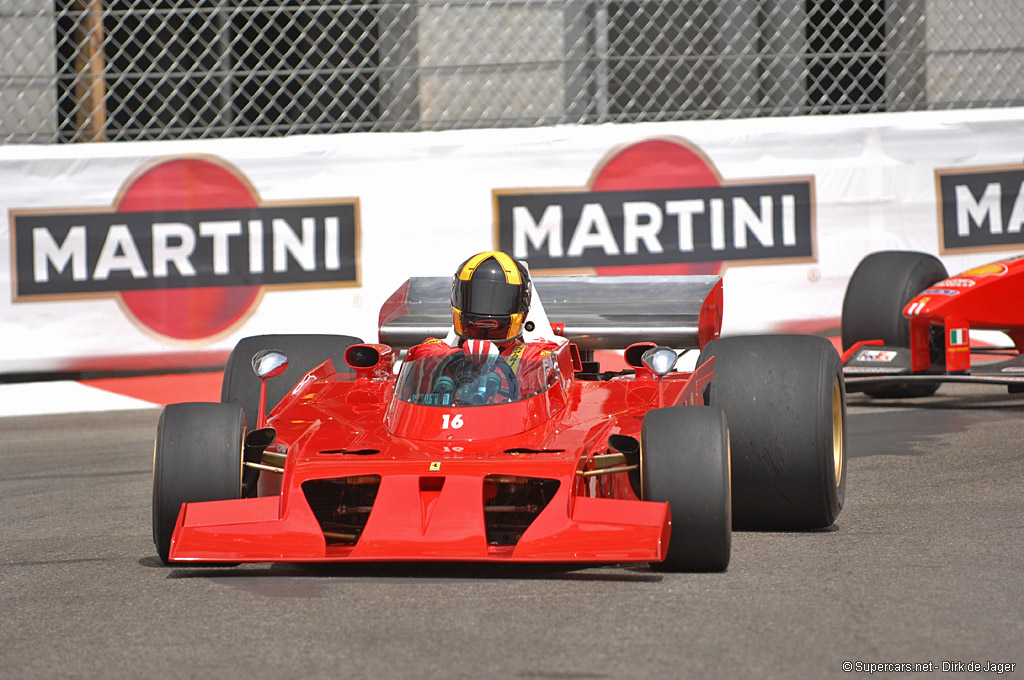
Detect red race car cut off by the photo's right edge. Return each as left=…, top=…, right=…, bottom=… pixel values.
left=843, top=251, right=1024, bottom=398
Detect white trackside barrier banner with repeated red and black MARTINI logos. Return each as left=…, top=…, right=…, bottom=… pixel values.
left=0, top=109, right=1024, bottom=373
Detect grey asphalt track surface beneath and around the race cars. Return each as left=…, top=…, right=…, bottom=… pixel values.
left=0, top=386, right=1024, bottom=680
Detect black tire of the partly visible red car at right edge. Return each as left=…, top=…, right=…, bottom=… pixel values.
left=843, top=250, right=948, bottom=398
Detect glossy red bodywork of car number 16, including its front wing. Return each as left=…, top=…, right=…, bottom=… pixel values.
left=170, top=340, right=720, bottom=562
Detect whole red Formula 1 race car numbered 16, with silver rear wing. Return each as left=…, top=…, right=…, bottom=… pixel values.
left=153, top=277, right=846, bottom=571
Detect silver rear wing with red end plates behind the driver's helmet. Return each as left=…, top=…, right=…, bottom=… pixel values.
left=378, top=275, right=722, bottom=349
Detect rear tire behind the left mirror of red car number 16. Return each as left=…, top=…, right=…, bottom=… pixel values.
left=220, top=335, right=362, bottom=429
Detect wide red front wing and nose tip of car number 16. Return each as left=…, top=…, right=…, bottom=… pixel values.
left=170, top=474, right=672, bottom=563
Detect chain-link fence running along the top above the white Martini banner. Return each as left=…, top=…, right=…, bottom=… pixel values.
left=0, top=0, right=1024, bottom=143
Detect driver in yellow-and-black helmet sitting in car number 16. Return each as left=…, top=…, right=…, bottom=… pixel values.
left=408, top=251, right=558, bottom=398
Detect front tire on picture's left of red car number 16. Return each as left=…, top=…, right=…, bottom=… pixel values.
left=153, top=403, right=246, bottom=562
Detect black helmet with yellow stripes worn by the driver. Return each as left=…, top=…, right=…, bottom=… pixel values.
left=452, top=251, right=530, bottom=342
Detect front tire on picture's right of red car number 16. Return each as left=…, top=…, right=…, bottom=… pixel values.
left=640, top=406, right=732, bottom=571
